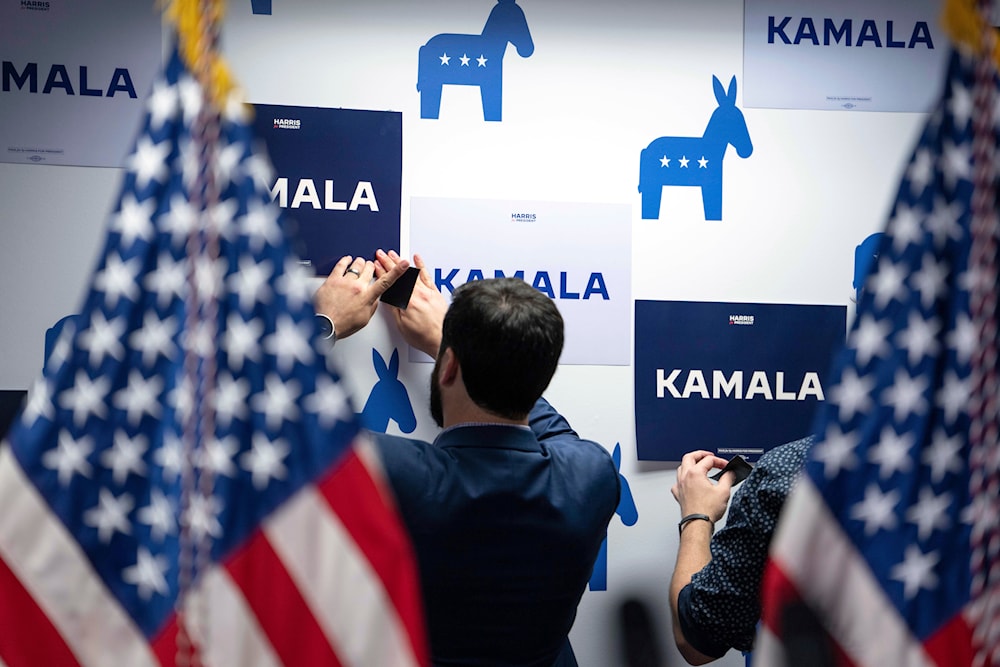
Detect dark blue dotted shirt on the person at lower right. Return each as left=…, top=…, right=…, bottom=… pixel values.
left=677, top=436, right=813, bottom=658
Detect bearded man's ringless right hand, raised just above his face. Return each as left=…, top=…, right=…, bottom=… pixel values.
left=375, top=250, right=448, bottom=357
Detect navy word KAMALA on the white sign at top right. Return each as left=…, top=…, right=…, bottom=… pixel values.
left=767, top=16, right=934, bottom=50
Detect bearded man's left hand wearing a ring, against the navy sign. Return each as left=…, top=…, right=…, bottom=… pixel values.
left=313, top=250, right=410, bottom=338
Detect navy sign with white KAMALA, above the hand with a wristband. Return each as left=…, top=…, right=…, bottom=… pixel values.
left=635, top=301, right=847, bottom=461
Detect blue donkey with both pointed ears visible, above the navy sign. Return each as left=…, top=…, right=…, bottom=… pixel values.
left=639, top=76, right=753, bottom=220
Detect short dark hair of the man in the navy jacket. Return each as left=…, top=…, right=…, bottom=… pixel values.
left=441, top=278, right=563, bottom=419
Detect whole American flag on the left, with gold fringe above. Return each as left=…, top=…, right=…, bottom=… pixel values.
left=0, top=44, right=427, bottom=667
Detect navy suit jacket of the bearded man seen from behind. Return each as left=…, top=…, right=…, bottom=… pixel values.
left=374, top=399, right=619, bottom=667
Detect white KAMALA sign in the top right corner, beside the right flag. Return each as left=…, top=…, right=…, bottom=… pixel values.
left=743, top=0, right=950, bottom=112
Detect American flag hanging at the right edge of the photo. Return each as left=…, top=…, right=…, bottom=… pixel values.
left=754, top=45, right=1000, bottom=667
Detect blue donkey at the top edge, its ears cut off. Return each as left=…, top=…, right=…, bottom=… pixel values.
left=417, top=0, right=535, bottom=121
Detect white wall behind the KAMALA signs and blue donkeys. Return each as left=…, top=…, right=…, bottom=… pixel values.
left=0, top=0, right=926, bottom=667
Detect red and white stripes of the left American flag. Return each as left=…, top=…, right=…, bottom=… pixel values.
left=0, top=438, right=428, bottom=667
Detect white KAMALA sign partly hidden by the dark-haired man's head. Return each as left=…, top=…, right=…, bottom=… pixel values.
left=410, top=197, right=632, bottom=366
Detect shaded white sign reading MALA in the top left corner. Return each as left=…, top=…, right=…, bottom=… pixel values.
left=0, top=0, right=163, bottom=167
